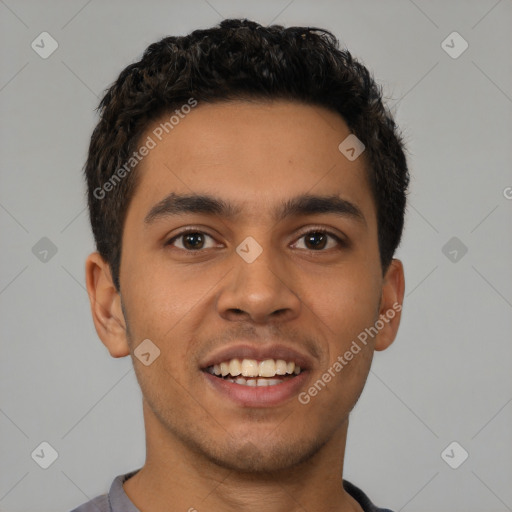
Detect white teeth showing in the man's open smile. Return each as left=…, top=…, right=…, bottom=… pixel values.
left=208, top=359, right=301, bottom=378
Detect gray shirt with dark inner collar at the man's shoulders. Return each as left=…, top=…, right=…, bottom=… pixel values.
left=71, top=468, right=392, bottom=512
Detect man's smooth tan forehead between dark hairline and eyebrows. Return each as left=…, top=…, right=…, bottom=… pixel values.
left=129, top=101, right=374, bottom=226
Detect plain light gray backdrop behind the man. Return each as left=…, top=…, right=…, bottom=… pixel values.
left=0, top=0, right=512, bottom=512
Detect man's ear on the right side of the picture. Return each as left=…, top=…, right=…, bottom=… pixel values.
left=375, top=259, right=405, bottom=350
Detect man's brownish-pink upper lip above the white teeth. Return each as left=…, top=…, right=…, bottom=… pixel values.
left=200, top=343, right=312, bottom=370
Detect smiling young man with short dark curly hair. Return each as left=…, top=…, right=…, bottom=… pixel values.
left=74, top=20, right=409, bottom=512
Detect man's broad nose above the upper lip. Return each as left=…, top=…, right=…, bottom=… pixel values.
left=217, top=240, right=301, bottom=324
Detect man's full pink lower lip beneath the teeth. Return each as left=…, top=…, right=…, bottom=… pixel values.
left=202, top=370, right=309, bottom=407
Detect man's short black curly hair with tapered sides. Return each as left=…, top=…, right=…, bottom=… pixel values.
left=84, top=19, right=409, bottom=291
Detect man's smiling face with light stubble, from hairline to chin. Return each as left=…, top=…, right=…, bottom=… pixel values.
left=90, top=101, right=403, bottom=472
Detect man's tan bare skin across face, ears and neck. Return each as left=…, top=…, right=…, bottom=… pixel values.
left=86, top=101, right=404, bottom=512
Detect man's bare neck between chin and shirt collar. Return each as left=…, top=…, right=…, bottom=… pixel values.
left=124, top=400, right=362, bottom=512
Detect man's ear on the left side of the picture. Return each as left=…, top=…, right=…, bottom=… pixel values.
left=85, top=252, right=130, bottom=357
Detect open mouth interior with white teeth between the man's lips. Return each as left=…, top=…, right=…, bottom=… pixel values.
left=204, top=358, right=303, bottom=387
